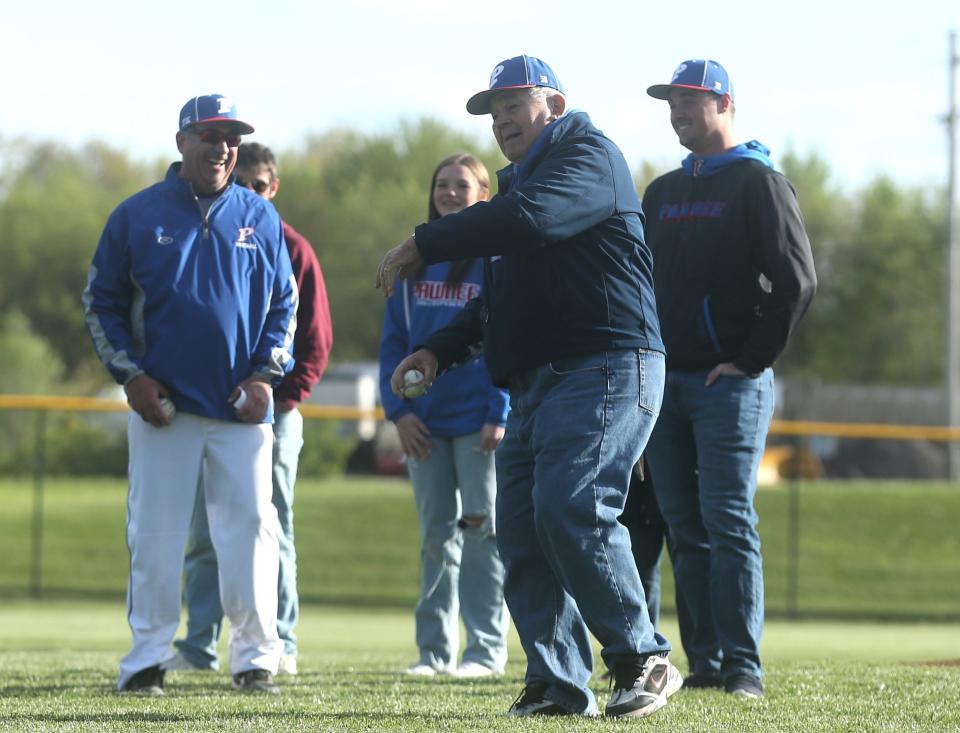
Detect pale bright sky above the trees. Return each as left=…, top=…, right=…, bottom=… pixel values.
left=0, top=0, right=960, bottom=189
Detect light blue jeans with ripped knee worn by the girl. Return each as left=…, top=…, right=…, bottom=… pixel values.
left=407, top=432, right=508, bottom=672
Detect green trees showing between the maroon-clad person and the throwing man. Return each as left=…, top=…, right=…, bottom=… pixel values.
left=277, top=119, right=503, bottom=361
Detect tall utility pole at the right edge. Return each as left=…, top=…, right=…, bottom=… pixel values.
left=946, top=31, right=960, bottom=481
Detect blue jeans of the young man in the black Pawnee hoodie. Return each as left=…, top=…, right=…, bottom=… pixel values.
left=647, top=369, right=774, bottom=678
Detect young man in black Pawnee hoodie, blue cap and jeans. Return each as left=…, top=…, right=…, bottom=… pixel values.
left=643, top=59, right=817, bottom=698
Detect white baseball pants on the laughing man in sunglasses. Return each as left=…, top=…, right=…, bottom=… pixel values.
left=117, top=412, right=283, bottom=690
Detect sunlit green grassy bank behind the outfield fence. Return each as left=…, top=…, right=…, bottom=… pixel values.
left=0, top=478, right=960, bottom=620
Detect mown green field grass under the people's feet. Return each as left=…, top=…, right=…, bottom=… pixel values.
left=0, top=602, right=960, bottom=733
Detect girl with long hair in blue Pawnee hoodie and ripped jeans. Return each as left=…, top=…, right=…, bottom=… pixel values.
left=380, top=154, right=510, bottom=677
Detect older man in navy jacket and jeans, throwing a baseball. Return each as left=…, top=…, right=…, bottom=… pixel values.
left=378, top=56, right=682, bottom=717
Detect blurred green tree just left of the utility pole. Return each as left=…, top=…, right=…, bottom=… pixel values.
left=818, top=177, right=946, bottom=386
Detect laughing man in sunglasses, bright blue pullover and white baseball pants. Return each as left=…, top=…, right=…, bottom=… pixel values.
left=83, top=94, right=297, bottom=695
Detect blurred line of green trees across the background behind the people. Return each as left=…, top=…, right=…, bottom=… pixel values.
left=0, top=119, right=947, bottom=394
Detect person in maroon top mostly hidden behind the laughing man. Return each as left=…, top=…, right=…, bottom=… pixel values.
left=172, top=143, right=333, bottom=674
